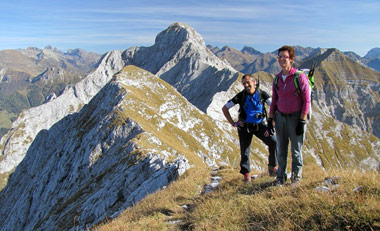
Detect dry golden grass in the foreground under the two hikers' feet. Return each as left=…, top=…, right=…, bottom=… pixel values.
left=95, top=166, right=380, bottom=231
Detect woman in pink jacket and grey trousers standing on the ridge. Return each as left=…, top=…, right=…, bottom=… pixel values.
left=268, top=46, right=310, bottom=186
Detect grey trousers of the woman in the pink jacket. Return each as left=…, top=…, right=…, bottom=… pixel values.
left=275, top=112, right=306, bottom=183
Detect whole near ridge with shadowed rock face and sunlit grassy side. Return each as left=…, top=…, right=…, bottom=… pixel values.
left=0, top=66, right=236, bottom=230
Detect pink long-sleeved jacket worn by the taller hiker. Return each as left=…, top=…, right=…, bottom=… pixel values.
left=269, top=67, right=310, bottom=115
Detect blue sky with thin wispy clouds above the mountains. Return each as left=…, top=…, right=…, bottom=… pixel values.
left=0, top=0, right=380, bottom=56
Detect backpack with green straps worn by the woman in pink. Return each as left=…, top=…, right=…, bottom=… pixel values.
left=274, top=62, right=317, bottom=119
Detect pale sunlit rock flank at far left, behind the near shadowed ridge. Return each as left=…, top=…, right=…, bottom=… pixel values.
left=0, top=51, right=124, bottom=173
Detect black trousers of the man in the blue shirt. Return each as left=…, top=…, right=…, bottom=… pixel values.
left=238, top=123, right=277, bottom=174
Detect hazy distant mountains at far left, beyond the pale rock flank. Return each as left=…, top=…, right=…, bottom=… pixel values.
left=0, top=46, right=101, bottom=137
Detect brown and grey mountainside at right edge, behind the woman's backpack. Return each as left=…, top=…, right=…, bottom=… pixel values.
left=301, top=49, right=380, bottom=137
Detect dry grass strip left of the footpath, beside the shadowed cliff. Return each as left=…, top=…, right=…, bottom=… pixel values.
left=95, top=168, right=210, bottom=231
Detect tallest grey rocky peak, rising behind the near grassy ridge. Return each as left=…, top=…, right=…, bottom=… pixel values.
left=123, top=23, right=238, bottom=112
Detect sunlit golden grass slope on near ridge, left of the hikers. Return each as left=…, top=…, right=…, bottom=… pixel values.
left=112, top=66, right=237, bottom=166
